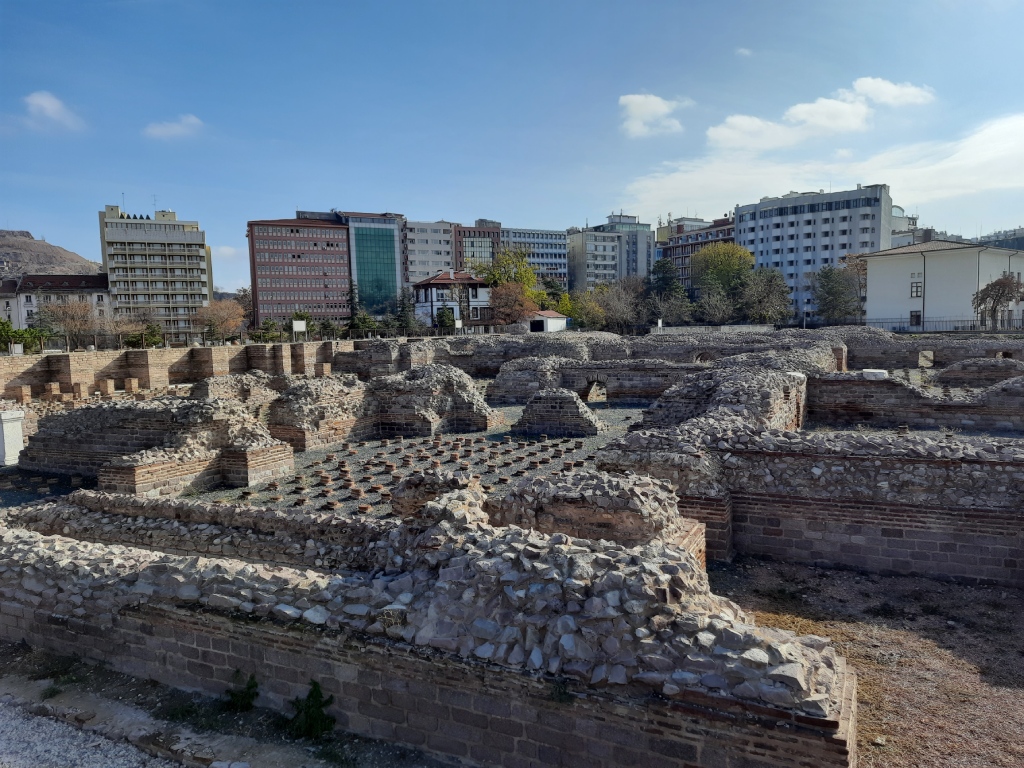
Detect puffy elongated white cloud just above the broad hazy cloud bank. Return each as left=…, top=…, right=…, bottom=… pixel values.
left=708, top=78, right=934, bottom=152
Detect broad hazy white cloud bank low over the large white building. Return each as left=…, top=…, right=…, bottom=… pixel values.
left=616, top=114, right=1024, bottom=222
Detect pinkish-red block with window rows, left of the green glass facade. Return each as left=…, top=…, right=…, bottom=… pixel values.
left=246, top=217, right=351, bottom=326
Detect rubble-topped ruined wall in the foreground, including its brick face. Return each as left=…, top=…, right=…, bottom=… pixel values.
left=0, top=489, right=855, bottom=768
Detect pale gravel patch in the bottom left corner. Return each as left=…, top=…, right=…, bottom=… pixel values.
left=0, top=702, right=177, bottom=768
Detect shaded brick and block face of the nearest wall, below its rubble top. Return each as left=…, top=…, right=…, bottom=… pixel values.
left=0, top=598, right=856, bottom=768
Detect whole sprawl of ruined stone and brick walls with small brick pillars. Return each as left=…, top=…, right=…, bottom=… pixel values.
left=0, top=328, right=1024, bottom=768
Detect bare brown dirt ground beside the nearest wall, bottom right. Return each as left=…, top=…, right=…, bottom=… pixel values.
left=710, top=558, right=1024, bottom=768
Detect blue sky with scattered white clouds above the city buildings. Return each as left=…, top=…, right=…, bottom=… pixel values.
left=0, top=0, right=1024, bottom=288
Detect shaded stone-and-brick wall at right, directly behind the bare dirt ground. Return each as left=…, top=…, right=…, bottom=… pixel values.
left=598, top=420, right=1024, bottom=586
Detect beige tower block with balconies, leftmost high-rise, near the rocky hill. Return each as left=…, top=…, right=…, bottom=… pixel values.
left=99, top=206, right=213, bottom=341
